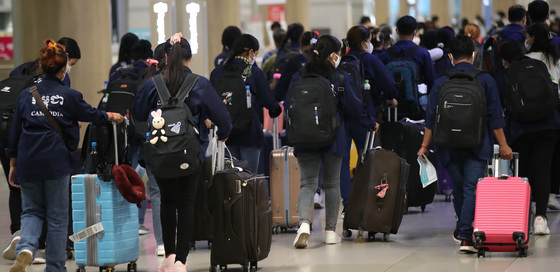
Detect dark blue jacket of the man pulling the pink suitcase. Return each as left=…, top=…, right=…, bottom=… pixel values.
left=419, top=62, right=506, bottom=166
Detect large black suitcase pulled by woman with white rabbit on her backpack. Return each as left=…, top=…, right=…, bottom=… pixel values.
left=210, top=142, right=272, bottom=271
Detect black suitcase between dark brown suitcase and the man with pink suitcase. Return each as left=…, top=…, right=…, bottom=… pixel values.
left=399, top=119, right=437, bottom=211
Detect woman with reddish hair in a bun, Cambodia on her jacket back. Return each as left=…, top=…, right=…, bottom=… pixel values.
left=7, top=39, right=123, bottom=272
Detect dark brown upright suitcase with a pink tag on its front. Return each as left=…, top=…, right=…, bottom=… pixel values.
left=343, top=132, right=410, bottom=241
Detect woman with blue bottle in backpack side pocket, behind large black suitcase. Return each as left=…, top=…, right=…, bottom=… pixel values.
left=210, top=34, right=282, bottom=173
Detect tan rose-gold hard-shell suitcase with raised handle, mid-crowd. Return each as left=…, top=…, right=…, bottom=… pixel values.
left=270, top=118, right=314, bottom=234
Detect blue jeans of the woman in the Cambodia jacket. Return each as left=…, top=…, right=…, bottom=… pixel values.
left=16, top=175, right=70, bottom=272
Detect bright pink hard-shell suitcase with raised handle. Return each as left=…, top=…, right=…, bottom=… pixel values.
left=473, top=153, right=531, bottom=257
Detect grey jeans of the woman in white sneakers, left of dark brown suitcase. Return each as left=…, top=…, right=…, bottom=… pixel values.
left=297, top=152, right=342, bottom=231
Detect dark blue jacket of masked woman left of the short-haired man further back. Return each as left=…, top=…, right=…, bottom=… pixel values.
left=348, top=49, right=397, bottom=100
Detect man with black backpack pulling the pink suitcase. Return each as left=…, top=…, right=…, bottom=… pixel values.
left=417, top=35, right=513, bottom=253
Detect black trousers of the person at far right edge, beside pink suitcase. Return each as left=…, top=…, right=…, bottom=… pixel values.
left=512, top=130, right=558, bottom=216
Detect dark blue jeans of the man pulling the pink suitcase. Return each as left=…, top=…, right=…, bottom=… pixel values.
left=446, top=150, right=487, bottom=241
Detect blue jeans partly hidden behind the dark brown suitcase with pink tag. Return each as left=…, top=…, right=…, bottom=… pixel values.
left=340, top=119, right=367, bottom=206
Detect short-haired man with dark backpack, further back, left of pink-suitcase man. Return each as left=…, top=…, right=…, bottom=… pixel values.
left=387, top=15, right=435, bottom=120
